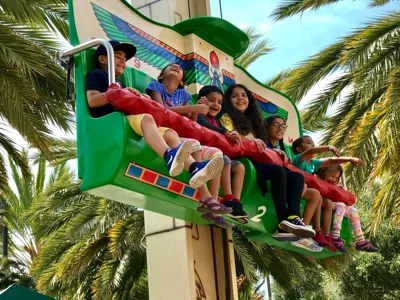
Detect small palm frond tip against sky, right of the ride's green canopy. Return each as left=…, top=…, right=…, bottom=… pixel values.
left=235, top=26, right=273, bottom=68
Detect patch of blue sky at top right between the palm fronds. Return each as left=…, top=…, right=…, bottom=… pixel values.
left=210, top=0, right=399, bottom=81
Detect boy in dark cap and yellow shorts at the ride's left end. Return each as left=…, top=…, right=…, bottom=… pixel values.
left=86, top=41, right=222, bottom=192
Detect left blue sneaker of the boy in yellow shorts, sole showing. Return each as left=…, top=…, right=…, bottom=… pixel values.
left=165, top=141, right=192, bottom=177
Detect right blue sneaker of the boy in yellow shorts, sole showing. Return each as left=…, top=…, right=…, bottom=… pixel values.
left=189, top=156, right=224, bottom=189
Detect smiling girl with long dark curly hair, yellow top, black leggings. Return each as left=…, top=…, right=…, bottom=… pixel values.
left=221, top=84, right=315, bottom=241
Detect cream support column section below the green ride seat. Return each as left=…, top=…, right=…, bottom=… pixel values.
left=145, top=211, right=238, bottom=300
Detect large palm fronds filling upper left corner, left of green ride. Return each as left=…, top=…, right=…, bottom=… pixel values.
left=0, top=0, right=73, bottom=188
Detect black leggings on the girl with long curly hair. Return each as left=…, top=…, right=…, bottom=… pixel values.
left=258, top=164, right=304, bottom=222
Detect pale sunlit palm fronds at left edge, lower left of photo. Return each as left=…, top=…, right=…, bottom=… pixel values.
left=0, top=150, right=46, bottom=288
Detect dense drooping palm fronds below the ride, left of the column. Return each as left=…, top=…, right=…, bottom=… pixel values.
left=27, top=155, right=148, bottom=300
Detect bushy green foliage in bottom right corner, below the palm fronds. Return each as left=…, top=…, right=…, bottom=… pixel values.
left=273, top=184, right=400, bottom=300
